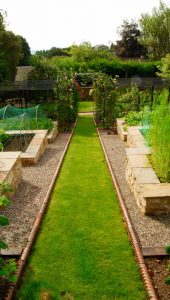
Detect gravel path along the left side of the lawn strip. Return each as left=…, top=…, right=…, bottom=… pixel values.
left=1, top=133, right=70, bottom=247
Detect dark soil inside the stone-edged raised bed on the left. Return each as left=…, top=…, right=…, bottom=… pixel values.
left=3, top=134, right=34, bottom=152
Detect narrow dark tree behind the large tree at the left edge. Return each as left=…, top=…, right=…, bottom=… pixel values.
left=18, top=35, right=31, bottom=66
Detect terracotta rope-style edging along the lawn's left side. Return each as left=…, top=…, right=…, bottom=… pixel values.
left=5, top=118, right=78, bottom=300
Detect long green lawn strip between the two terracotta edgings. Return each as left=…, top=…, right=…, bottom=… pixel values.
left=15, top=116, right=147, bottom=300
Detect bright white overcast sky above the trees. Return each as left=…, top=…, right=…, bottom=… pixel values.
left=0, top=0, right=170, bottom=51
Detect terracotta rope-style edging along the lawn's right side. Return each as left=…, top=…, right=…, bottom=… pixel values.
left=94, top=127, right=158, bottom=300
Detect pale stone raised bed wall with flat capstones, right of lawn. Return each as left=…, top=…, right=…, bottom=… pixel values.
left=118, top=122, right=170, bottom=215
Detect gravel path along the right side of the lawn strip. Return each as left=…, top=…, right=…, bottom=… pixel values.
left=100, top=131, right=170, bottom=247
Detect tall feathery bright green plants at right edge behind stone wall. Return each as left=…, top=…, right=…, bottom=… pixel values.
left=148, top=93, right=170, bottom=182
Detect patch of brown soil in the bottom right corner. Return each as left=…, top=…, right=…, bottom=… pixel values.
left=145, top=256, right=170, bottom=300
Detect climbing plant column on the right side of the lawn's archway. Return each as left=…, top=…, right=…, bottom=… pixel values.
left=93, top=74, right=117, bottom=128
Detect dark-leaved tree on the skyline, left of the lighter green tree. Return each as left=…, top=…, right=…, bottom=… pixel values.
left=112, top=20, right=145, bottom=58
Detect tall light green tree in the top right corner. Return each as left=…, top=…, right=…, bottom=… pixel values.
left=139, top=2, right=170, bottom=60
